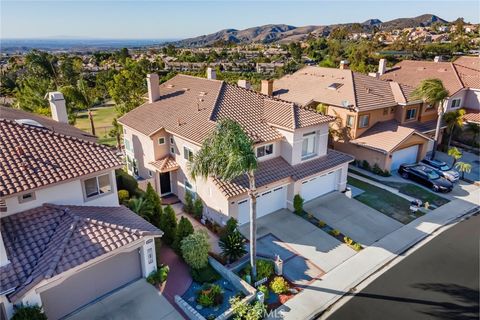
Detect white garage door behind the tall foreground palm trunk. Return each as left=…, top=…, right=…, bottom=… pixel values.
left=238, top=186, right=287, bottom=225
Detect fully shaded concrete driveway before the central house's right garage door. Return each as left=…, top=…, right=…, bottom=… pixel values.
left=304, top=192, right=403, bottom=246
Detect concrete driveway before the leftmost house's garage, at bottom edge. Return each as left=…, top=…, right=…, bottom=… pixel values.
left=67, top=279, right=183, bottom=320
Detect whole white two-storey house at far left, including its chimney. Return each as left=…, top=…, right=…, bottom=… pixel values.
left=0, top=96, right=162, bottom=320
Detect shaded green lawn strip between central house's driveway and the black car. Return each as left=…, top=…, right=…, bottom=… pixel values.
left=348, top=177, right=420, bottom=224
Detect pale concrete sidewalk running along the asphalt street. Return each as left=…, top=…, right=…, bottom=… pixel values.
left=271, top=188, right=480, bottom=319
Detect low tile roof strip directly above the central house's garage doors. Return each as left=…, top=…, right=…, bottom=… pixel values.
left=214, top=150, right=353, bottom=198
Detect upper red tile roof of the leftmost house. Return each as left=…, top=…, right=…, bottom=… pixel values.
left=0, top=119, right=122, bottom=197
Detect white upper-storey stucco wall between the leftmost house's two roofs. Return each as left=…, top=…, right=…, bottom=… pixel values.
left=0, top=170, right=118, bottom=217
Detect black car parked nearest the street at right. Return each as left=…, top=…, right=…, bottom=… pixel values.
left=398, top=164, right=453, bottom=192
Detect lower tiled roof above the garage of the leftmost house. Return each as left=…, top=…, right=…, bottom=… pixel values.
left=0, top=204, right=162, bottom=301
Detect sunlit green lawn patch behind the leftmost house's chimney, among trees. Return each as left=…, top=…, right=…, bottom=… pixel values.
left=75, top=107, right=117, bottom=146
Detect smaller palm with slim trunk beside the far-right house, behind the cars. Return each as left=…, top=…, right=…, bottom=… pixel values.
left=412, top=79, right=449, bottom=159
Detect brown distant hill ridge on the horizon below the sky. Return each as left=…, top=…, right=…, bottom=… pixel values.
left=172, top=14, right=448, bottom=47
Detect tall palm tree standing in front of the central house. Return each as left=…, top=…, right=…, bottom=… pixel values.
left=189, top=119, right=257, bottom=280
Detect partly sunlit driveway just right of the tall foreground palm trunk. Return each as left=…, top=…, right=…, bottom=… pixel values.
left=239, top=209, right=355, bottom=278
